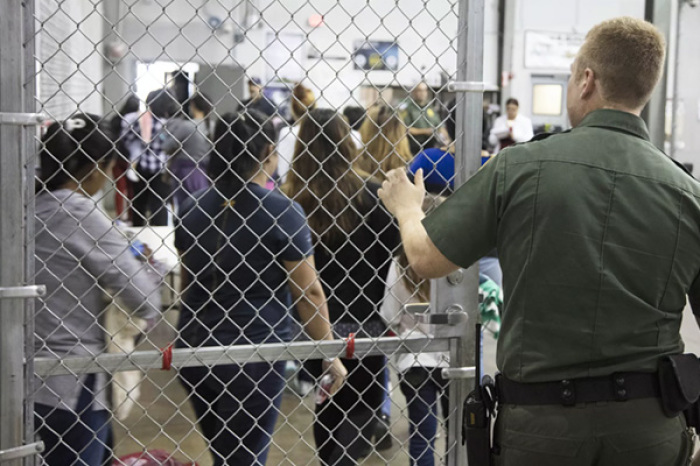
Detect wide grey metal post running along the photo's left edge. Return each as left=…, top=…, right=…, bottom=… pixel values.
left=0, top=0, right=27, bottom=466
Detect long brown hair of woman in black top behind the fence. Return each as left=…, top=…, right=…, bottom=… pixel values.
left=283, top=108, right=364, bottom=244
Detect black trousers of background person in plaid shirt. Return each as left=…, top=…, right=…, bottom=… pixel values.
left=131, top=173, right=172, bottom=226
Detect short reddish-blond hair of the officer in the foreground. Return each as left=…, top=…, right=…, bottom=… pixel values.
left=573, top=16, right=666, bottom=108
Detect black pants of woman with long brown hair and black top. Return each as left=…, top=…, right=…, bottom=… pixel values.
left=314, top=356, right=386, bottom=466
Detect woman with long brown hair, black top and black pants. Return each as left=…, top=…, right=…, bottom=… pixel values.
left=284, top=109, right=400, bottom=465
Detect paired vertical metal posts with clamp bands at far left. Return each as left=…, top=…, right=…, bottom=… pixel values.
left=0, top=0, right=43, bottom=466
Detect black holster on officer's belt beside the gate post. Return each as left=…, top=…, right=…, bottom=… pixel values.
left=462, top=375, right=497, bottom=466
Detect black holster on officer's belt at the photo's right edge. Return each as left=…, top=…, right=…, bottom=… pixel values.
left=659, top=353, right=700, bottom=428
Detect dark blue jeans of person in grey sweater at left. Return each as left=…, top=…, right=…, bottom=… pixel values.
left=34, top=375, right=111, bottom=466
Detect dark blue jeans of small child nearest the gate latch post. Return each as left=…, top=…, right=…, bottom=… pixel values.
left=401, top=367, right=449, bottom=466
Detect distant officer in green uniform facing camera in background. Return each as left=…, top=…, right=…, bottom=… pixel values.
left=399, top=81, right=445, bottom=155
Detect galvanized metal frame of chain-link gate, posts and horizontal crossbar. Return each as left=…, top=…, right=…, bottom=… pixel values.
left=0, top=0, right=484, bottom=466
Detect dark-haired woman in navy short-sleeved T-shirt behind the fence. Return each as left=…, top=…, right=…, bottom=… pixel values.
left=175, top=110, right=346, bottom=465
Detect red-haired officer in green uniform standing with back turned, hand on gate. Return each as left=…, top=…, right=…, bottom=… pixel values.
left=379, top=17, right=700, bottom=466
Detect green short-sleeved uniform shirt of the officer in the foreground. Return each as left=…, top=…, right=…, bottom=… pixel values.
left=423, top=110, right=700, bottom=382
